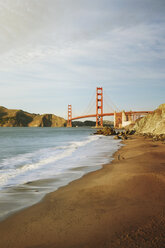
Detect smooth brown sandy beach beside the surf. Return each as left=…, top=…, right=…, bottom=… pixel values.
left=0, top=136, right=165, bottom=248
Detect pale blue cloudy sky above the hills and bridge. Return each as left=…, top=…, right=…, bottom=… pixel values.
left=0, top=0, right=165, bottom=117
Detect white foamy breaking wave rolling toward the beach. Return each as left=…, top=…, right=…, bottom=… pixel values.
left=0, top=136, right=99, bottom=188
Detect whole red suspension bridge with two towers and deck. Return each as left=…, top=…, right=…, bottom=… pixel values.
left=67, top=87, right=153, bottom=128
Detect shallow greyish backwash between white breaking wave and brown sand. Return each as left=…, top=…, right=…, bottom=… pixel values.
left=0, top=137, right=122, bottom=222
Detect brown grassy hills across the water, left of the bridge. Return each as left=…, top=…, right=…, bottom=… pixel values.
left=0, top=106, right=66, bottom=127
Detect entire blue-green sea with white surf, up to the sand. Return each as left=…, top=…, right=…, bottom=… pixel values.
left=0, top=127, right=121, bottom=220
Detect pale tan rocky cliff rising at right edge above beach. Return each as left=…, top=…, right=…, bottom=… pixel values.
left=130, top=104, right=165, bottom=135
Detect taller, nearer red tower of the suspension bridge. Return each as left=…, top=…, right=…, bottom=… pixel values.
left=96, top=87, right=103, bottom=127
